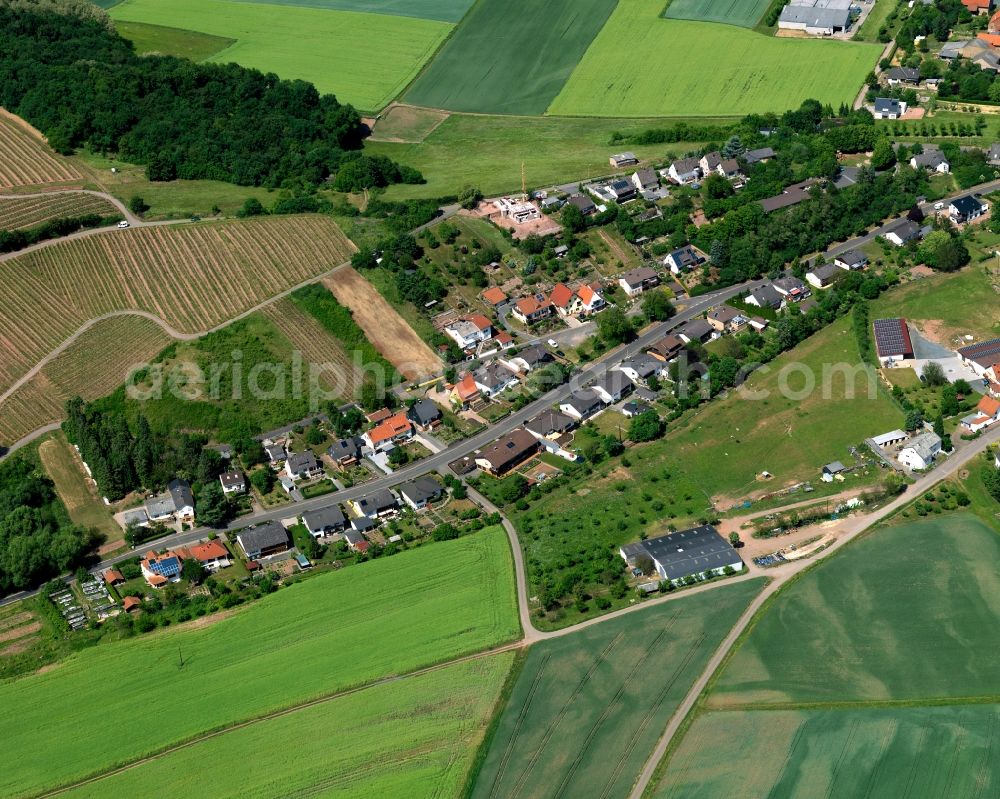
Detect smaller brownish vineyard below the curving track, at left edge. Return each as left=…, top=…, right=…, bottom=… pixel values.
left=0, top=316, right=171, bottom=443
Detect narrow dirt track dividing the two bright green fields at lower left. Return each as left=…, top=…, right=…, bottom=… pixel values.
left=33, top=639, right=525, bottom=799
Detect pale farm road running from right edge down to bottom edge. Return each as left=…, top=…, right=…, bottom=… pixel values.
left=629, top=426, right=1000, bottom=799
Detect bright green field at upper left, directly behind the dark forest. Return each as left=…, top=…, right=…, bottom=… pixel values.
left=110, top=0, right=452, bottom=111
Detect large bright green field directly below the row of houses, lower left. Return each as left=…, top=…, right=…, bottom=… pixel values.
left=0, top=527, right=518, bottom=797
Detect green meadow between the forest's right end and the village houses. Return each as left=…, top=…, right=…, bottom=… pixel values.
left=365, top=109, right=733, bottom=199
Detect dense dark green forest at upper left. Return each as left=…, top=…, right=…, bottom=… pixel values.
left=0, top=0, right=421, bottom=188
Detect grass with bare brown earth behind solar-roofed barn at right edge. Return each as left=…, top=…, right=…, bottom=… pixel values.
left=871, top=261, right=1000, bottom=347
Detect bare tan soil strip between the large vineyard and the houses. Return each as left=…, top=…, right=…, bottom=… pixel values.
left=323, top=267, right=441, bottom=380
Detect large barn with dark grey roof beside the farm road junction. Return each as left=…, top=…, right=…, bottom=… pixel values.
left=619, top=524, right=743, bottom=582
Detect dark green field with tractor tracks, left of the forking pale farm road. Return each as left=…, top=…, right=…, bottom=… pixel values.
left=472, top=580, right=763, bottom=799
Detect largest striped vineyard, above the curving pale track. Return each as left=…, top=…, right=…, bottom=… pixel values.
left=0, top=216, right=353, bottom=406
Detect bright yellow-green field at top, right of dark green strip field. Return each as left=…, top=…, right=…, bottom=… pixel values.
left=548, top=0, right=881, bottom=117
